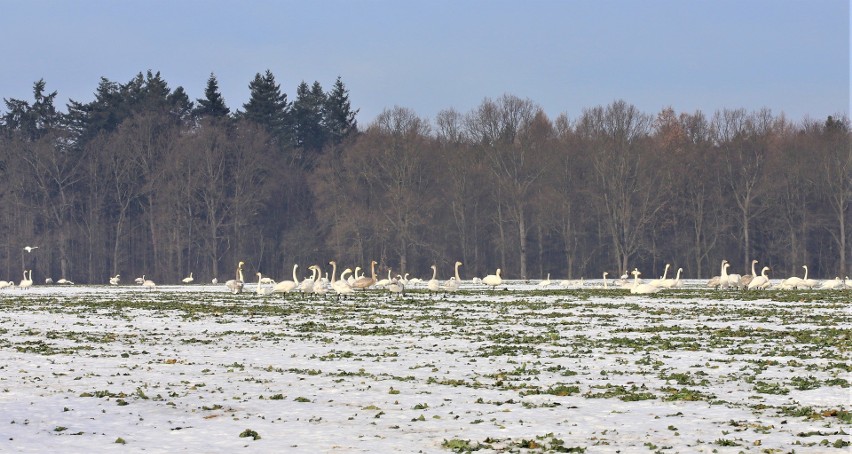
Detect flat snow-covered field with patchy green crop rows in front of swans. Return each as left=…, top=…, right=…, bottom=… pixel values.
left=0, top=282, right=852, bottom=453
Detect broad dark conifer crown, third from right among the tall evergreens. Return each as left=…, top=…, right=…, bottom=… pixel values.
left=240, top=69, right=293, bottom=149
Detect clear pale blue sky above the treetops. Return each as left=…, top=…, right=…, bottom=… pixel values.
left=0, top=0, right=850, bottom=126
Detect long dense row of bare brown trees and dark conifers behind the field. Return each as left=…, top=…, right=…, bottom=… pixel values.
left=0, top=71, right=852, bottom=283
